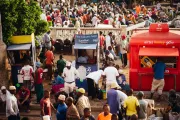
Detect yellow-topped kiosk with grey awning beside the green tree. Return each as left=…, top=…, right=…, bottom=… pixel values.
left=7, top=34, right=36, bottom=85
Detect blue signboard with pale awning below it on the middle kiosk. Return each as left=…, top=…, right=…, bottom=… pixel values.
left=74, top=34, right=98, bottom=49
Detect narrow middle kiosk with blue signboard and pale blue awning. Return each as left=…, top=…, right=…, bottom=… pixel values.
left=74, top=34, right=99, bottom=90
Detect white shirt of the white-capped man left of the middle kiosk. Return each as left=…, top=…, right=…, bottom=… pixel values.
left=62, top=66, right=79, bottom=82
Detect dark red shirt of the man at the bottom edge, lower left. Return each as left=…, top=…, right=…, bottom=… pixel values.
left=40, top=98, right=51, bottom=116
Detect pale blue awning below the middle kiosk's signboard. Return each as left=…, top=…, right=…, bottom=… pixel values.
left=74, top=43, right=97, bottom=49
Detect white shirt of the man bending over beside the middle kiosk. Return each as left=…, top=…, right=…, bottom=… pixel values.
left=86, top=70, right=103, bottom=84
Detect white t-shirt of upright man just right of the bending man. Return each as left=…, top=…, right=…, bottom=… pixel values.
left=103, top=66, right=119, bottom=83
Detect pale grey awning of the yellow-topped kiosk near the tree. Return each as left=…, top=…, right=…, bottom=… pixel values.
left=7, top=44, right=31, bottom=50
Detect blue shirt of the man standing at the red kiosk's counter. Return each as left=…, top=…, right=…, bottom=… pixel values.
left=154, top=62, right=166, bottom=80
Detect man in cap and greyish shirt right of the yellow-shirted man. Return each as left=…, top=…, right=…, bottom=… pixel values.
left=137, top=91, right=150, bottom=120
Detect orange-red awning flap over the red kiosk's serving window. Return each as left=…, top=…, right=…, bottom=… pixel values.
left=139, top=48, right=179, bottom=57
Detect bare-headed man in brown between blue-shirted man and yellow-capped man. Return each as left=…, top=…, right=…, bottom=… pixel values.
left=66, top=97, right=80, bottom=120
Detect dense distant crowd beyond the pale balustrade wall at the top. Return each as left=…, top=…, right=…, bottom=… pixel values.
left=40, top=0, right=179, bottom=29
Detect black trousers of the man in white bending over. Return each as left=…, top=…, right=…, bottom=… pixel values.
left=87, top=78, right=97, bottom=99
